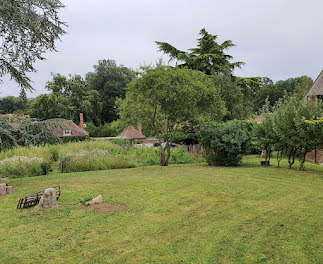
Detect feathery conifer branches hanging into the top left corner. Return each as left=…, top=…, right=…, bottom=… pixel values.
left=0, top=0, right=65, bottom=89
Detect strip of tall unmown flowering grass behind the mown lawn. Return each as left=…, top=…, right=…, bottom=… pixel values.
left=0, top=140, right=204, bottom=177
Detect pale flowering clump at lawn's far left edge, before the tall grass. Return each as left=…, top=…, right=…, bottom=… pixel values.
left=0, top=156, right=43, bottom=178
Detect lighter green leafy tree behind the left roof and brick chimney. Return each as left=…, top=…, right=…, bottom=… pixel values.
left=30, top=74, right=102, bottom=124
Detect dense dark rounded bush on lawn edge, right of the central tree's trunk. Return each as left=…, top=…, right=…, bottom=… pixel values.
left=201, top=120, right=252, bottom=166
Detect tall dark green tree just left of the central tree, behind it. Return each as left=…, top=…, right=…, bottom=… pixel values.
left=86, top=60, right=135, bottom=124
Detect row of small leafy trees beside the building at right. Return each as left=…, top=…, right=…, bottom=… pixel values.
left=257, top=97, right=323, bottom=169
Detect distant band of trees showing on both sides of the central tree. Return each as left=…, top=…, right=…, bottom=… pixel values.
left=0, top=60, right=313, bottom=126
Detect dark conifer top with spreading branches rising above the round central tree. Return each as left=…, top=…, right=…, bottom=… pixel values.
left=156, top=28, right=244, bottom=75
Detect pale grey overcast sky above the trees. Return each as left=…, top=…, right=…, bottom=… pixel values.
left=0, top=0, right=323, bottom=97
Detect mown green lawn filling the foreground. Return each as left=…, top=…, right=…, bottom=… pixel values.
left=0, top=156, right=323, bottom=264
